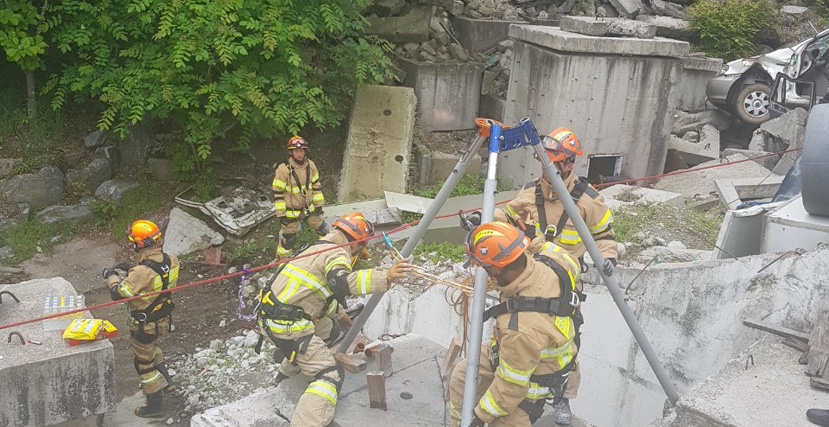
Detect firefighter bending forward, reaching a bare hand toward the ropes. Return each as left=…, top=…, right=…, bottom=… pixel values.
left=257, top=212, right=411, bottom=427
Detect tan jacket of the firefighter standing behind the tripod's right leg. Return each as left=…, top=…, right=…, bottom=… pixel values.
left=494, top=173, right=618, bottom=258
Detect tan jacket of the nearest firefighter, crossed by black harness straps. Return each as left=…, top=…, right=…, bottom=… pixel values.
left=475, top=250, right=579, bottom=424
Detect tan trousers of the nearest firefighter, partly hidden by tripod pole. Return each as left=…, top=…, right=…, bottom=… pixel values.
left=449, top=344, right=532, bottom=427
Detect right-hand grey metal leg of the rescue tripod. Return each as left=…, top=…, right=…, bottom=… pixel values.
left=533, top=144, right=679, bottom=405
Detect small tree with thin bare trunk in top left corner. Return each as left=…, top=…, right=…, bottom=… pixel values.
left=0, top=0, right=46, bottom=123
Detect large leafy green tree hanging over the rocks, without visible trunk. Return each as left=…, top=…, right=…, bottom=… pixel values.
left=46, top=0, right=392, bottom=176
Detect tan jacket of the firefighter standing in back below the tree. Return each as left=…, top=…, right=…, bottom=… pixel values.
left=273, top=156, right=325, bottom=218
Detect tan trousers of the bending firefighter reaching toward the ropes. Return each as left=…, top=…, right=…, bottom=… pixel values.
left=270, top=335, right=342, bottom=427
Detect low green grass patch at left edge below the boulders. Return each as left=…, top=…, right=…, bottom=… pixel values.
left=0, top=218, right=77, bottom=263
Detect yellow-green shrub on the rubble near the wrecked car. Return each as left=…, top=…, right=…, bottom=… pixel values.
left=688, top=0, right=777, bottom=61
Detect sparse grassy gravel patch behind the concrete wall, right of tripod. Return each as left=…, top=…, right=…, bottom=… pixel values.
left=613, top=204, right=723, bottom=250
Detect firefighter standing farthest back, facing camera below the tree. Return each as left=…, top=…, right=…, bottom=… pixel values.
left=273, top=136, right=328, bottom=259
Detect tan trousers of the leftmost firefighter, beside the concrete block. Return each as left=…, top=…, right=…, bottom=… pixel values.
left=129, top=318, right=168, bottom=396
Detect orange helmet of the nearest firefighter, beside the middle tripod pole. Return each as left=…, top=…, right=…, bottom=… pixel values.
left=466, top=222, right=530, bottom=267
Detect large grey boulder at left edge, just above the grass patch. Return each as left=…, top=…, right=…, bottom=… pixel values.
left=0, top=166, right=63, bottom=208
